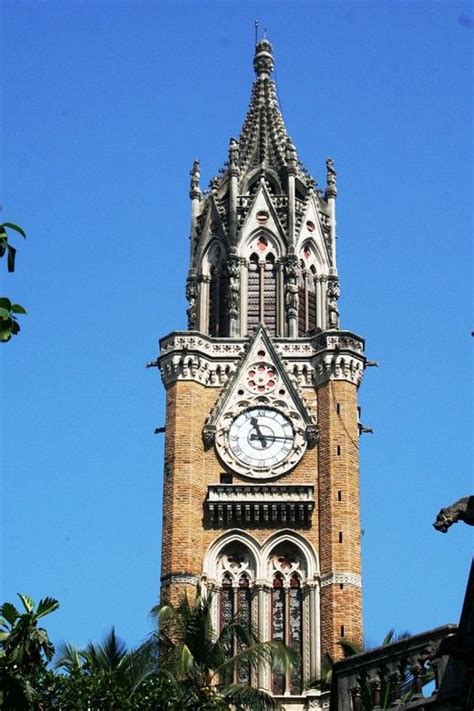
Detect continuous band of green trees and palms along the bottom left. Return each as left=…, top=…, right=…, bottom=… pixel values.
left=0, top=588, right=297, bottom=711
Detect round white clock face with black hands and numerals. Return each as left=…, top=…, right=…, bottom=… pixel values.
left=229, top=407, right=295, bottom=470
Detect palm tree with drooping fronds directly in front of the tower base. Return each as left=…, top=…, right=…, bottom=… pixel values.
left=151, top=587, right=297, bottom=711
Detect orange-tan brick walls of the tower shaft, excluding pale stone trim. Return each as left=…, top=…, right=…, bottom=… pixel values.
left=162, top=381, right=362, bottom=657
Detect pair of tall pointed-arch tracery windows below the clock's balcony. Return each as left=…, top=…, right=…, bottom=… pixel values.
left=204, top=532, right=320, bottom=696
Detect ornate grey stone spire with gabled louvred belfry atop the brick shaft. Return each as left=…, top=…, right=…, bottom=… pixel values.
left=186, top=38, right=339, bottom=338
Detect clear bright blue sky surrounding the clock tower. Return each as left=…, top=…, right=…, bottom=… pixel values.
left=1, top=0, right=474, bottom=656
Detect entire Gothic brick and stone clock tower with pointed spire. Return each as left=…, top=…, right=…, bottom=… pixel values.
left=159, top=39, right=366, bottom=709
